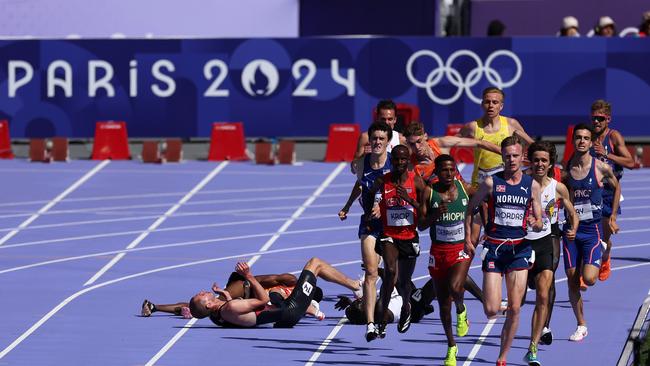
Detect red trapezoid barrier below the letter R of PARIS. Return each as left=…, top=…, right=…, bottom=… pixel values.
left=92, top=121, right=131, bottom=160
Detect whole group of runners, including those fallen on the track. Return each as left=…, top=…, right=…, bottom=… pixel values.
left=142, top=87, right=634, bottom=365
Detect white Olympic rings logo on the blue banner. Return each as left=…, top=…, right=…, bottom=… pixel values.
left=406, top=50, right=522, bottom=105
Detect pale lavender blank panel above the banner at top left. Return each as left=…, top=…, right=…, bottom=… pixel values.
left=0, top=0, right=299, bottom=38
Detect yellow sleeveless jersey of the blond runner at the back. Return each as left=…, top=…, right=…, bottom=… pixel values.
left=472, top=116, right=511, bottom=184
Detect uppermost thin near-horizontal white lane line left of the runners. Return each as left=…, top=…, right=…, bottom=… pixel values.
left=0, top=183, right=350, bottom=207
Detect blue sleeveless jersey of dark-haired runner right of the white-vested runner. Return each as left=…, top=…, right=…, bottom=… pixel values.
left=567, top=158, right=603, bottom=226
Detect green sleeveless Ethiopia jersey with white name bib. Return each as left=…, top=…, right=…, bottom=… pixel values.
left=429, top=179, right=469, bottom=244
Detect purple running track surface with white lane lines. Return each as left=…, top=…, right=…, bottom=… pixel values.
left=0, top=160, right=650, bottom=365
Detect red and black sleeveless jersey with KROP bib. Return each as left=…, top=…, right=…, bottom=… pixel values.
left=379, top=171, right=418, bottom=240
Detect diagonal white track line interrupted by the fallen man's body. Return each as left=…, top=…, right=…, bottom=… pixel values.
left=145, top=163, right=347, bottom=366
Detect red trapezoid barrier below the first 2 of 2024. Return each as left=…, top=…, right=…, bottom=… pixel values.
left=208, top=122, right=248, bottom=161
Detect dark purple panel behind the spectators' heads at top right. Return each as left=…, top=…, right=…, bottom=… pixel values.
left=471, top=0, right=650, bottom=37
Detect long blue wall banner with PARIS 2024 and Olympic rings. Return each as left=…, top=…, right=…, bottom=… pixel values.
left=0, top=37, right=650, bottom=138
